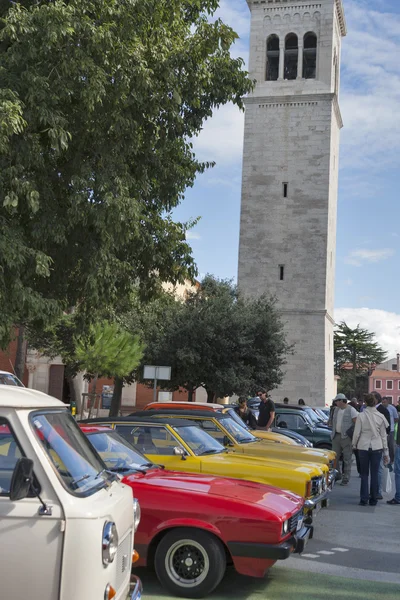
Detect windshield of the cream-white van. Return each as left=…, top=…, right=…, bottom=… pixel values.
left=31, top=410, right=113, bottom=496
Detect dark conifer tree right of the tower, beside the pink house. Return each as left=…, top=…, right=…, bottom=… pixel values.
left=334, top=321, right=387, bottom=397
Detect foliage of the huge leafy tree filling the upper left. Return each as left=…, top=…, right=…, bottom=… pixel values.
left=0, top=0, right=251, bottom=345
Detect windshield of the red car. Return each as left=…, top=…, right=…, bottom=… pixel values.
left=86, top=431, right=155, bottom=473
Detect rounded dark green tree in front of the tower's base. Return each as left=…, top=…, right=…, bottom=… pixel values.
left=144, top=276, right=290, bottom=401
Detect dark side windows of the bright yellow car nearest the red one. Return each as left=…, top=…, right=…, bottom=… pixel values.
left=120, top=425, right=182, bottom=456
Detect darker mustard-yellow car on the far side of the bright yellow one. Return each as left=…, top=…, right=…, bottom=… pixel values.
left=137, top=409, right=337, bottom=487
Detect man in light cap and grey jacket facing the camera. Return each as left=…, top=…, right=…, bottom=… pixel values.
left=331, top=394, right=358, bottom=485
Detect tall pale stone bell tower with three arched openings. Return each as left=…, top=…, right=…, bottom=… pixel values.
left=238, top=0, right=346, bottom=405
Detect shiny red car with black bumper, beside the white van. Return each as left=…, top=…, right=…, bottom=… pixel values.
left=81, top=425, right=313, bottom=598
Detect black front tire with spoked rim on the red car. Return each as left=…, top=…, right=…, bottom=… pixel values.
left=154, top=527, right=226, bottom=598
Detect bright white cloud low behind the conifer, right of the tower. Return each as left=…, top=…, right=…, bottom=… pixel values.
left=335, top=308, right=400, bottom=358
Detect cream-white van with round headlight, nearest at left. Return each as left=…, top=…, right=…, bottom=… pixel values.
left=0, top=386, right=142, bottom=600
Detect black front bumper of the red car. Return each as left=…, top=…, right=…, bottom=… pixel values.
left=227, top=525, right=314, bottom=561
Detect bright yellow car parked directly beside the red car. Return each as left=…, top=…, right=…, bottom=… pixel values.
left=86, top=416, right=328, bottom=510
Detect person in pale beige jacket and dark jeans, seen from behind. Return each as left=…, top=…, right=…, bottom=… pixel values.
left=352, top=394, right=389, bottom=506
